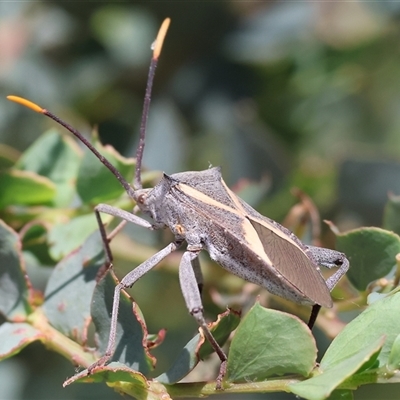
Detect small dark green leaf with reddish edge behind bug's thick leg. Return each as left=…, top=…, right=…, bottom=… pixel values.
left=156, top=310, right=240, bottom=385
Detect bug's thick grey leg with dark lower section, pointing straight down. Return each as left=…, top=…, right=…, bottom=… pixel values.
left=179, top=249, right=227, bottom=390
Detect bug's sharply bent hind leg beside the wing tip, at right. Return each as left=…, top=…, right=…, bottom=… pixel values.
left=308, top=246, right=350, bottom=329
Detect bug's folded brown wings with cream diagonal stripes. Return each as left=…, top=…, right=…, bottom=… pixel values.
left=174, top=175, right=332, bottom=307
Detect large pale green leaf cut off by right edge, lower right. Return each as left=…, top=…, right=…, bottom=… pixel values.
left=321, top=291, right=400, bottom=370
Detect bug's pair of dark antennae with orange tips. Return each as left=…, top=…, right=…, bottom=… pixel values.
left=7, top=18, right=170, bottom=198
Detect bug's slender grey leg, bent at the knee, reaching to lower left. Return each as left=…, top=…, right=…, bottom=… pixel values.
left=88, top=238, right=182, bottom=374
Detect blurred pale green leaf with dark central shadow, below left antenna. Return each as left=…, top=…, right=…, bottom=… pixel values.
left=16, top=129, right=81, bottom=207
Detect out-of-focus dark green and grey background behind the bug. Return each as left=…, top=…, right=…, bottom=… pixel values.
left=0, top=1, right=400, bottom=399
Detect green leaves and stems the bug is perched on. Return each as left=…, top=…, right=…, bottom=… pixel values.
left=0, top=126, right=400, bottom=400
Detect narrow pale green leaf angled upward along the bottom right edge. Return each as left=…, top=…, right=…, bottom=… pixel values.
left=289, top=336, right=385, bottom=400
